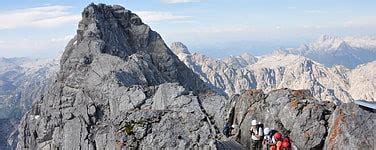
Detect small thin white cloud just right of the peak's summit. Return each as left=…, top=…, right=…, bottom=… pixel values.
left=136, top=11, right=190, bottom=22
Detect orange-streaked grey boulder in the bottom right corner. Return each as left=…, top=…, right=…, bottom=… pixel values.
left=325, top=103, right=376, bottom=150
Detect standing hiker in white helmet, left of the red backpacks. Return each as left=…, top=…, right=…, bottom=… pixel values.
left=249, top=120, right=264, bottom=150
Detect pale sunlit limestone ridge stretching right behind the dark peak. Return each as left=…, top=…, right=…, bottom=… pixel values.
left=172, top=43, right=376, bottom=102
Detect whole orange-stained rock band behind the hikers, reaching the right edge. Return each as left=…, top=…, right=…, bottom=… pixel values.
left=229, top=89, right=376, bottom=149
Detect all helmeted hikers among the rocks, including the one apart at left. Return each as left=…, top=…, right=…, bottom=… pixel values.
left=223, top=120, right=291, bottom=150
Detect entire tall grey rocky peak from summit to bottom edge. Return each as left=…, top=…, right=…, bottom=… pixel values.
left=17, top=4, right=226, bottom=149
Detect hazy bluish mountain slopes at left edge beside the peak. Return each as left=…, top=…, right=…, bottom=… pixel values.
left=0, top=58, right=58, bottom=149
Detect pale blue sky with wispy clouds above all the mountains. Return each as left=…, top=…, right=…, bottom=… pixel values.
left=0, top=0, right=376, bottom=57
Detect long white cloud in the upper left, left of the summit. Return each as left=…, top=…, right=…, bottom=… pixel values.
left=0, top=5, right=81, bottom=29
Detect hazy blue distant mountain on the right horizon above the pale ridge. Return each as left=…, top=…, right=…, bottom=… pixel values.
left=279, top=35, right=376, bottom=68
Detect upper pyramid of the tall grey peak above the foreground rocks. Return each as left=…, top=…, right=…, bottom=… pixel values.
left=59, top=4, right=206, bottom=91
